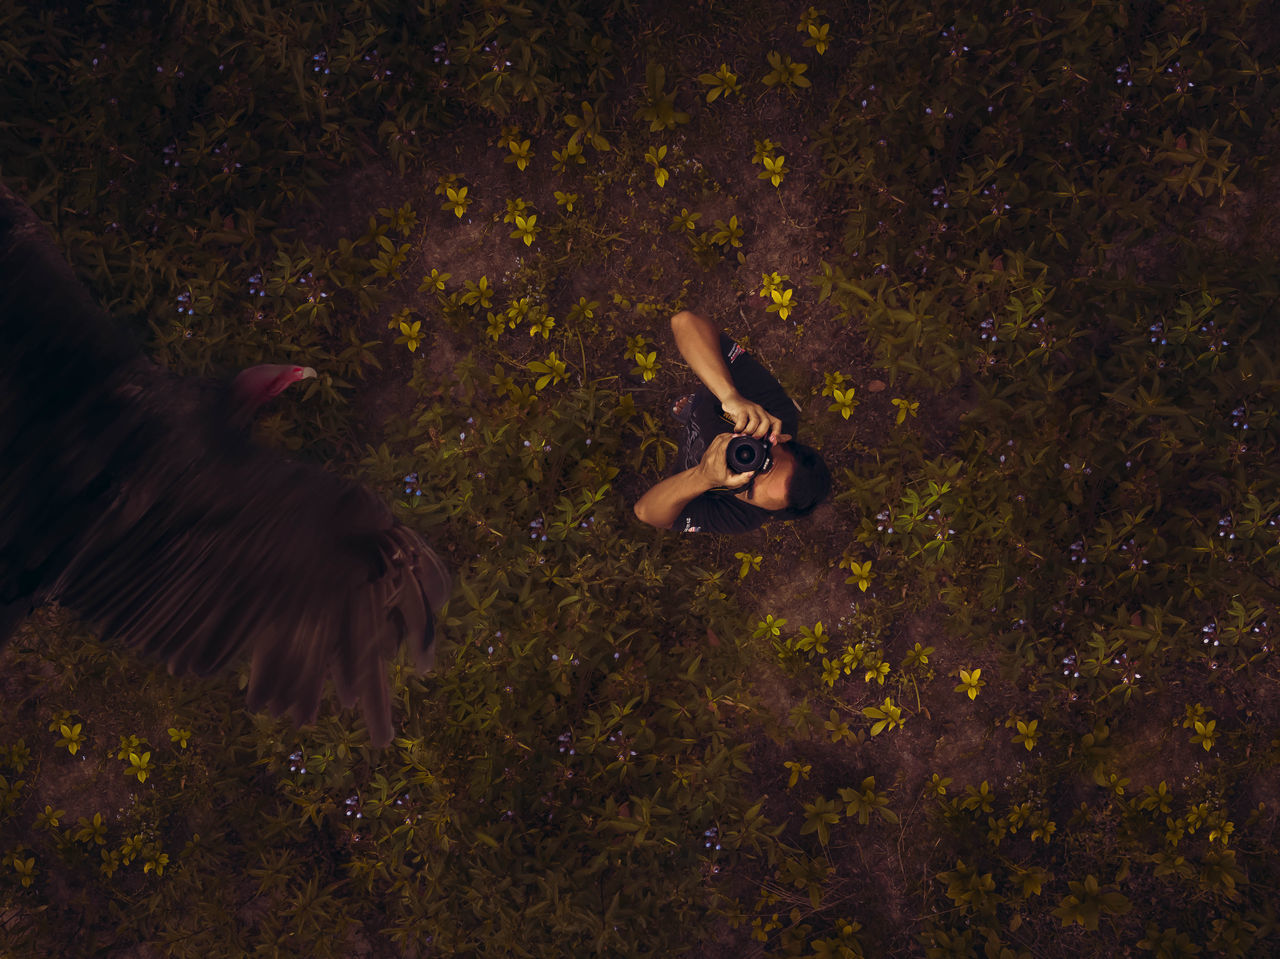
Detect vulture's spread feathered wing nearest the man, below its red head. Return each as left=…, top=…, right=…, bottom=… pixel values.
left=51, top=444, right=449, bottom=745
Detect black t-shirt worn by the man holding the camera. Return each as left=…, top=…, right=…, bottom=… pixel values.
left=673, top=333, right=800, bottom=533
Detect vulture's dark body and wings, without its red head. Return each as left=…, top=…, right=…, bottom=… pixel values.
left=0, top=181, right=449, bottom=745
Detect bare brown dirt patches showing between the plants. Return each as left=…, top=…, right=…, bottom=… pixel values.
left=10, top=13, right=1280, bottom=956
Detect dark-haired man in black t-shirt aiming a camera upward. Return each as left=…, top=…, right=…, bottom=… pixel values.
left=635, top=310, right=831, bottom=533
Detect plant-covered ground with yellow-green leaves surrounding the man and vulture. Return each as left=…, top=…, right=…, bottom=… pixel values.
left=0, top=0, right=1280, bottom=959
